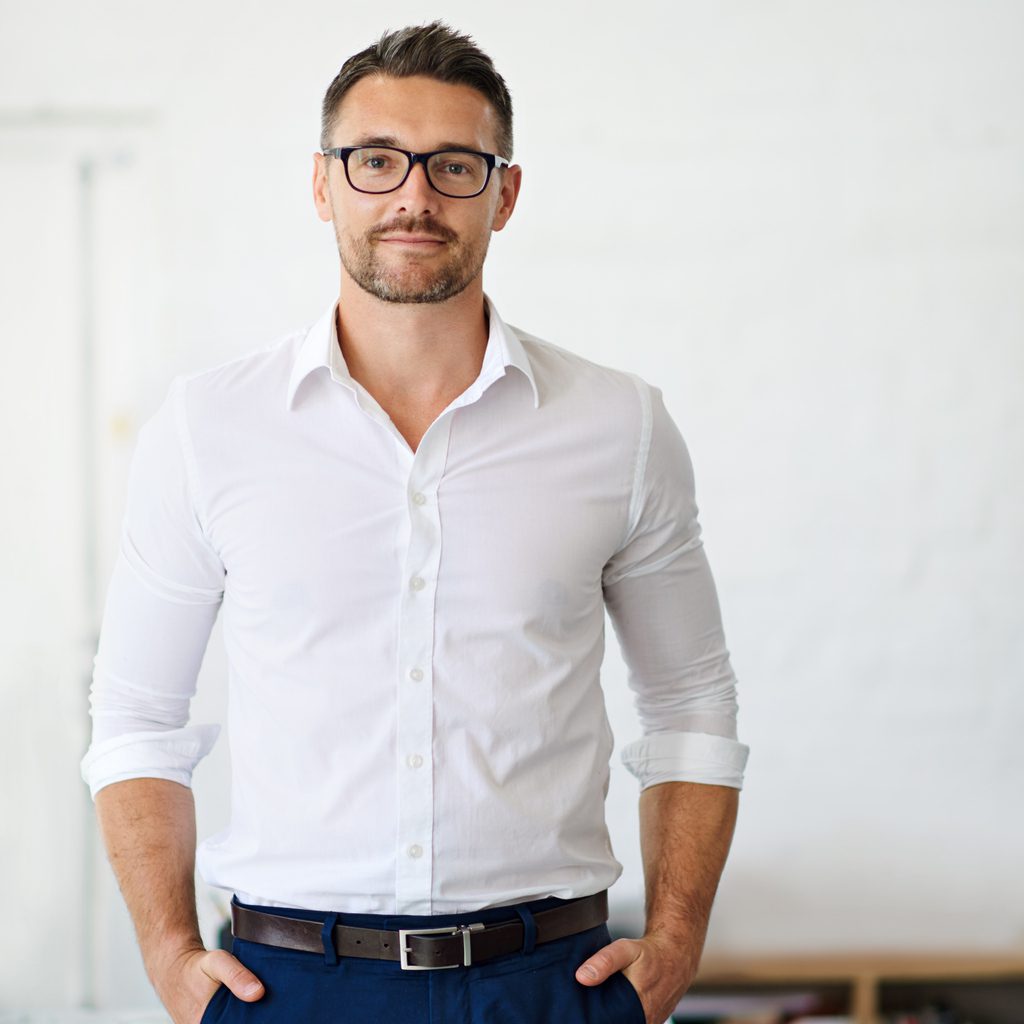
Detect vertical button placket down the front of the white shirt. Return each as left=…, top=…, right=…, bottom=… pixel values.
left=395, top=415, right=452, bottom=913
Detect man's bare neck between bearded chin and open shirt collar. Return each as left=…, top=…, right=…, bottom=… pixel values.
left=338, top=272, right=487, bottom=409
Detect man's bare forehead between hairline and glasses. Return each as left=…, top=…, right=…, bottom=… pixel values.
left=334, top=75, right=498, bottom=153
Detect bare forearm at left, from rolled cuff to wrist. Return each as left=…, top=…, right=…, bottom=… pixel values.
left=95, top=778, right=203, bottom=997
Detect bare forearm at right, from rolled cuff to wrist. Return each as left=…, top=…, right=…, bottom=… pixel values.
left=640, top=782, right=739, bottom=958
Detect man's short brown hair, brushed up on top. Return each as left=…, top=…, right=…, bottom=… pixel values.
left=321, top=22, right=512, bottom=160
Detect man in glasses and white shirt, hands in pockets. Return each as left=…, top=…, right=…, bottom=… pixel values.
left=83, top=24, right=746, bottom=1024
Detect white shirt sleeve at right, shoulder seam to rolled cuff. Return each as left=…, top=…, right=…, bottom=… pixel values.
left=602, top=380, right=749, bottom=790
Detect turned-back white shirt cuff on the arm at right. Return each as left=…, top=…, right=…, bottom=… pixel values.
left=622, top=732, right=750, bottom=790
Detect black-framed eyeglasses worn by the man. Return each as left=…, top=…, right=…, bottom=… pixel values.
left=321, top=145, right=509, bottom=199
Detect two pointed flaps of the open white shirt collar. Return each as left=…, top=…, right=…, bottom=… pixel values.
left=287, top=295, right=541, bottom=410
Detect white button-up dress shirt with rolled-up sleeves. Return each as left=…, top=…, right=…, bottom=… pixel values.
left=82, top=300, right=746, bottom=914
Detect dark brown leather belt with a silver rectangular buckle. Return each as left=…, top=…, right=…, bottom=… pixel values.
left=231, top=892, right=608, bottom=971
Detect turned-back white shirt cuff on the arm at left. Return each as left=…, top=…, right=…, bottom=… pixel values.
left=81, top=725, right=220, bottom=799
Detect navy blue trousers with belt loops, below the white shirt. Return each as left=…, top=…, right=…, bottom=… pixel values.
left=200, top=897, right=644, bottom=1024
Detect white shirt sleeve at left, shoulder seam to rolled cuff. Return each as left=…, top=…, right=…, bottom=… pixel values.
left=81, top=378, right=225, bottom=797
